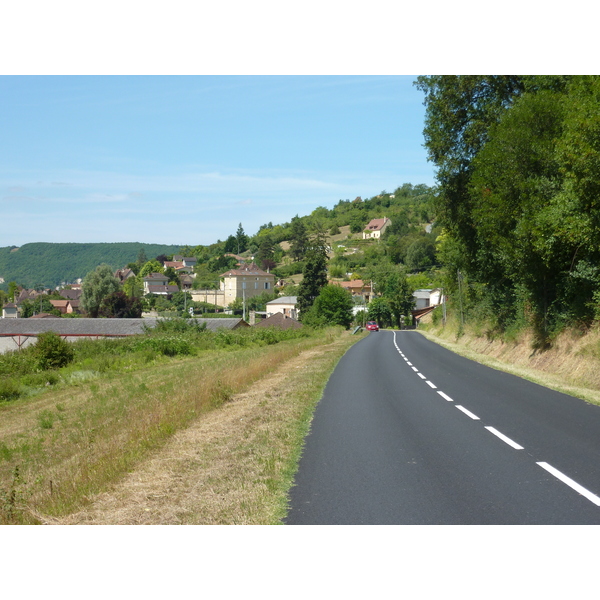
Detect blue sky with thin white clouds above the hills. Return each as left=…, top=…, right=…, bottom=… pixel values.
left=0, top=75, right=434, bottom=246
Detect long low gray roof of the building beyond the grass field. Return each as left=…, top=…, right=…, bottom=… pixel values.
left=0, top=317, right=247, bottom=336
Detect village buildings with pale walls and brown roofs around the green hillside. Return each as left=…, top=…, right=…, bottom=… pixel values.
left=0, top=217, right=443, bottom=352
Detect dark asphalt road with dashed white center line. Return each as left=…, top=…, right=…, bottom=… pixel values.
left=286, top=331, right=600, bottom=525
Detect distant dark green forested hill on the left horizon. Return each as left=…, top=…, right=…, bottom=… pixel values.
left=0, top=242, right=179, bottom=288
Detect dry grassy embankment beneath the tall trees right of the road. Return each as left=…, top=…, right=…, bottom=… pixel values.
left=419, top=322, right=600, bottom=405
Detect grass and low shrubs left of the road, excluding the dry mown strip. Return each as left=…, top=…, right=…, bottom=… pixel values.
left=0, top=320, right=355, bottom=523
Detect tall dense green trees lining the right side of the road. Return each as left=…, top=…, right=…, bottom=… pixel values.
left=417, top=76, right=600, bottom=348
